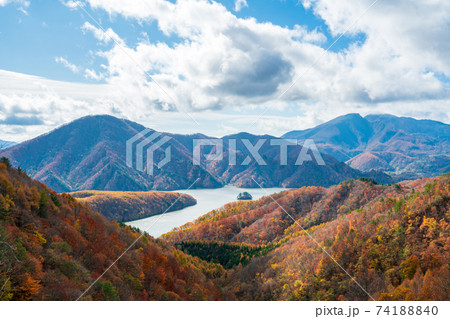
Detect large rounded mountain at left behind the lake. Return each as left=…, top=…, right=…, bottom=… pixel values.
left=1, top=115, right=221, bottom=192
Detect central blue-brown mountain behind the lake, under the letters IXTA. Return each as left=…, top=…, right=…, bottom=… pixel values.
left=200, top=133, right=392, bottom=188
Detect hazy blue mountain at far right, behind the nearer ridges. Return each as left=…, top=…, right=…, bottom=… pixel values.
left=283, top=114, right=450, bottom=178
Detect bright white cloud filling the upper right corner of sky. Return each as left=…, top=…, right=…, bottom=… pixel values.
left=302, top=0, right=450, bottom=97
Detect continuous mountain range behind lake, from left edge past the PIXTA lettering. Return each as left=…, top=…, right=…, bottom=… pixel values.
left=0, top=115, right=391, bottom=192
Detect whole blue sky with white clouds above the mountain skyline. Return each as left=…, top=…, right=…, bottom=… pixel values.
left=0, top=0, right=450, bottom=142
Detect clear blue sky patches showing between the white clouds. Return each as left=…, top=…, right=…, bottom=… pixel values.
left=0, top=0, right=363, bottom=83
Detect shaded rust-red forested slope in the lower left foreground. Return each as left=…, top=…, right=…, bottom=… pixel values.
left=0, top=164, right=225, bottom=300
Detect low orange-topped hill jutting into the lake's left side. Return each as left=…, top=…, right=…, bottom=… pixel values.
left=71, top=191, right=197, bottom=222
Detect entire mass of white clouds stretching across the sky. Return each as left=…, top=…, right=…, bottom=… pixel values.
left=0, top=0, right=450, bottom=141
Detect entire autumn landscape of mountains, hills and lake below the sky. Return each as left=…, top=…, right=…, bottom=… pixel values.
left=0, top=114, right=450, bottom=300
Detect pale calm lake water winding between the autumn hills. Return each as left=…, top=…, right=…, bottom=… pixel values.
left=126, top=186, right=286, bottom=237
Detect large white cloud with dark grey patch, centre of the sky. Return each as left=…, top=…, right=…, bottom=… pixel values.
left=78, top=0, right=326, bottom=110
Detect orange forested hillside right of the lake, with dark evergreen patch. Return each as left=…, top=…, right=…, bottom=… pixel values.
left=162, top=174, right=450, bottom=301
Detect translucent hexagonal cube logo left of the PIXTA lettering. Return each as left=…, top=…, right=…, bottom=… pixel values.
left=126, top=129, right=172, bottom=175
